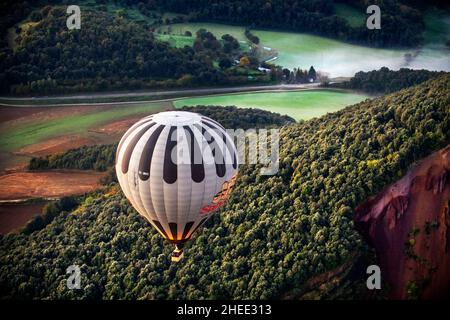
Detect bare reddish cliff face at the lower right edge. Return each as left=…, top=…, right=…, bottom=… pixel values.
left=354, top=145, right=450, bottom=299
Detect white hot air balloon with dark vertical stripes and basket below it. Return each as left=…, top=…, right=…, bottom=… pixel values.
left=116, top=111, right=238, bottom=262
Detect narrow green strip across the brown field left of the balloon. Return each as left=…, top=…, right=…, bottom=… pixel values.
left=0, top=103, right=167, bottom=152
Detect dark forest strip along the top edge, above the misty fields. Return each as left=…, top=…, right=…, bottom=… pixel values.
left=133, top=0, right=424, bottom=47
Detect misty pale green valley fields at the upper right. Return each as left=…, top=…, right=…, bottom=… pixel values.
left=158, top=10, right=450, bottom=77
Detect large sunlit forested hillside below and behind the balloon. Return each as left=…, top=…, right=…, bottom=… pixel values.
left=0, top=75, right=450, bottom=299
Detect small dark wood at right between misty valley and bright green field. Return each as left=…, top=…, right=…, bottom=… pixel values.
left=327, top=67, right=445, bottom=94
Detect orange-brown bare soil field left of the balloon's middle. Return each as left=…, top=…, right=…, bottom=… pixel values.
left=0, top=170, right=106, bottom=200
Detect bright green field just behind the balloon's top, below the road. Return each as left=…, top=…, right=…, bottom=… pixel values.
left=173, top=90, right=368, bottom=120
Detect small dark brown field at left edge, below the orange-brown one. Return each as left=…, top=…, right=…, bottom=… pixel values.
left=0, top=201, right=46, bottom=234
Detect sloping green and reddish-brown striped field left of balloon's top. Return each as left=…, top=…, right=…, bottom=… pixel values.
left=0, top=102, right=172, bottom=171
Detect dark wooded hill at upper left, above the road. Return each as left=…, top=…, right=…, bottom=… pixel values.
left=0, top=6, right=281, bottom=94
